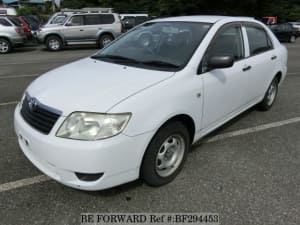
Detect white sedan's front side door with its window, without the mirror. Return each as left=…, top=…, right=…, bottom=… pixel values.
left=201, top=24, right=248, bottom=131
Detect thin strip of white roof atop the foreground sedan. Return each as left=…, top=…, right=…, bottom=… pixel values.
left=153, top=16, right=255, bottom=23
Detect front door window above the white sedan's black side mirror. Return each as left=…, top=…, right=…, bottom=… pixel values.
left=207, top=25, right=245, bottom=60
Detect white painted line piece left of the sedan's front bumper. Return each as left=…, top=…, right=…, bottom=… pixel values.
left=0, top=175, right=50, bottom=193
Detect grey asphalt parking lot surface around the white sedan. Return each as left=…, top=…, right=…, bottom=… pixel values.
left=0, top=40, right=300, bottom=225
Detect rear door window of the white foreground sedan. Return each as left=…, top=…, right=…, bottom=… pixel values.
left=246, top=26, right=273, bottom=56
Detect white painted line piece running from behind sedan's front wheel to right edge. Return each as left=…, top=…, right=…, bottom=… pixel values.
left=204, top=117, right=300, bottom=143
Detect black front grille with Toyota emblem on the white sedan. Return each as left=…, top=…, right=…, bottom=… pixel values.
left=21, top=96, right=61, bottom=134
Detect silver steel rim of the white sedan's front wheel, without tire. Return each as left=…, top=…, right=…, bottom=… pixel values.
left=156, top=135, right=185, bottom=177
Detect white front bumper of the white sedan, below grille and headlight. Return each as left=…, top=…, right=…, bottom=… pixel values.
left=14, top=106, right=153, bottom=191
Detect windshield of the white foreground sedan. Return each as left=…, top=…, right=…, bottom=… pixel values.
left=92, top=22, right=211, bottom=71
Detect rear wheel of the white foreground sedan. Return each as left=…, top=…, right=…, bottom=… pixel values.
left=258, top=77, right=279, bottom=111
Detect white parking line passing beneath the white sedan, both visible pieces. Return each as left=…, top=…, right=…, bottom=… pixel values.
left=0, top=117, right=300, bottom=193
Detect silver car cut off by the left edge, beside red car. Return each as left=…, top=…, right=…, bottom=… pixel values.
left=0, top=16, right=27, bottom=54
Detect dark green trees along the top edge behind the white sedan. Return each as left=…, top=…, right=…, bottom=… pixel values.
left=57, top=0, right=300, bottom=21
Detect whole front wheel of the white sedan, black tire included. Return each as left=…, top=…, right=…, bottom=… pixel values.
left=140, top=122, right=190, bottom=187
